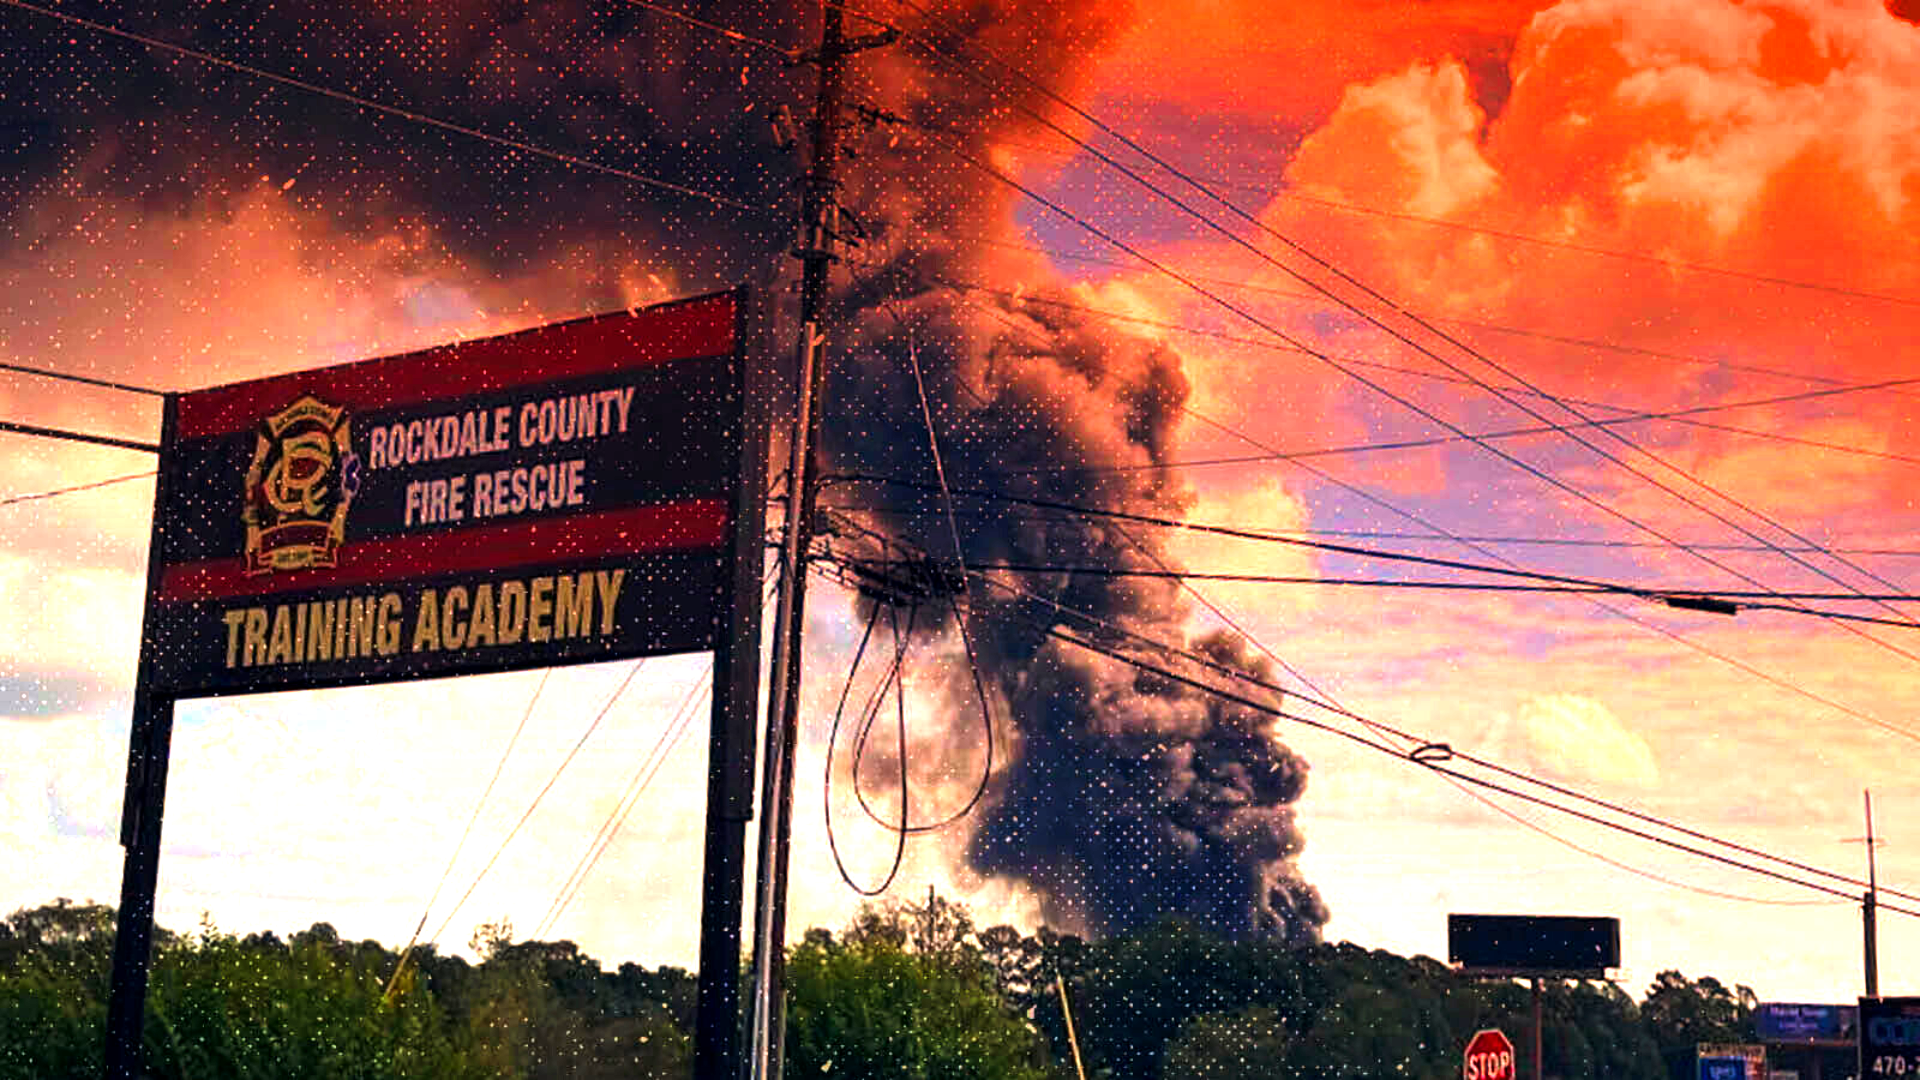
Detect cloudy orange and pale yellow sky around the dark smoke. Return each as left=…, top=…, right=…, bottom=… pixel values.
left=0, top=0, right=1920, bottom=1001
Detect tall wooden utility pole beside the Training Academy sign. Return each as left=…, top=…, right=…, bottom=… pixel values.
left=749, top=0, right=899, bottom=1080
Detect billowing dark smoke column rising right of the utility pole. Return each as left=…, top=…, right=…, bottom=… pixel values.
left=828, top=4, right=1327, bottom=942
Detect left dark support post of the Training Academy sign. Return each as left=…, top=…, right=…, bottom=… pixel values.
left=104, top=394, right=179, bottom=1080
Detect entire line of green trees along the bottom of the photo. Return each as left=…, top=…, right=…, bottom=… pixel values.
left=0, top=897, right=1781, bottom=1080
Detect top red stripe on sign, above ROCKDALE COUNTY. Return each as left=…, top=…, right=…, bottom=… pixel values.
left=179, top=292, right=735, bottom=438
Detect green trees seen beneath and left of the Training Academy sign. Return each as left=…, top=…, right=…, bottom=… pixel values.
left=0, top=901, right=693, bottom=1080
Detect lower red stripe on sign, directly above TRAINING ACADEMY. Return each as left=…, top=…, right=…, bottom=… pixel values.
left=159, top=500, right=728, bottom=603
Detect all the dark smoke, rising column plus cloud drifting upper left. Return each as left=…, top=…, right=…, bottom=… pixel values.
left=0, top=0, right=1327, bottom=942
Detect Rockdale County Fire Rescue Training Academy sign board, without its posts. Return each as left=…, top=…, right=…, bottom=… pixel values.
left=142, top=292, right=758, bottom=696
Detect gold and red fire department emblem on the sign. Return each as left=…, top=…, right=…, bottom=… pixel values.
left=242, top=396, right=361, bottom=575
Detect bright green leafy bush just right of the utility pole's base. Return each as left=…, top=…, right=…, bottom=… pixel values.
left=787, top=928, right=1046, bottom=1080
